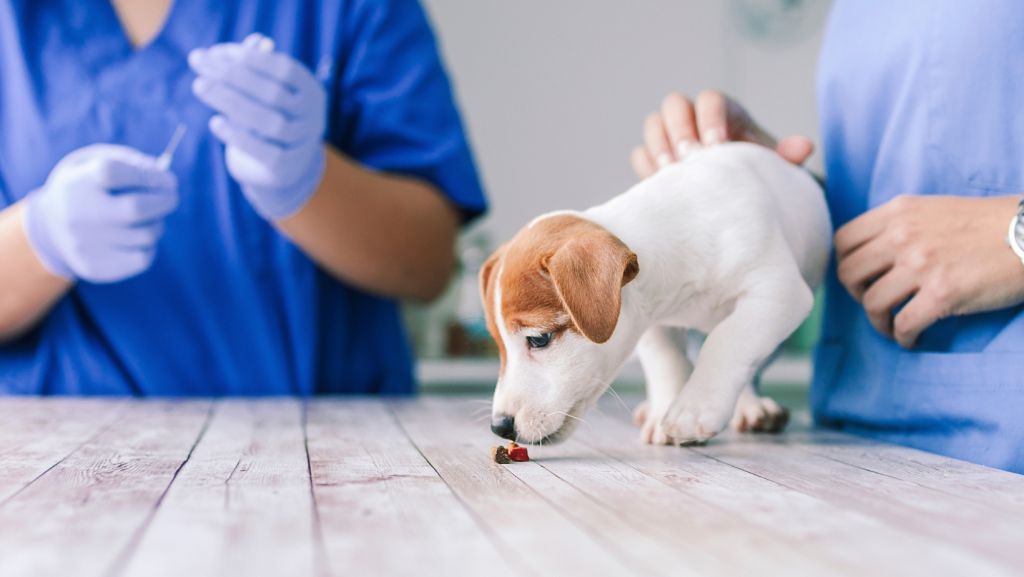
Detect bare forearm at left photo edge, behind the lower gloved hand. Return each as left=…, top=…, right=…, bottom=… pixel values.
left=0, top=204, right=71, bottom=342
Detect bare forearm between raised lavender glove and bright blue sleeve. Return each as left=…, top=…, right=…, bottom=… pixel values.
left=276, top=147, right=459, bottom=300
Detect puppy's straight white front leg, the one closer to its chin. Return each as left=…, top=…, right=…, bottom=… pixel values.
left=635, top=327, right=693, bottom=445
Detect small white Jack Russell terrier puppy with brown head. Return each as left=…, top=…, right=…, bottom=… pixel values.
left=480, top=142, right=831, bottom=444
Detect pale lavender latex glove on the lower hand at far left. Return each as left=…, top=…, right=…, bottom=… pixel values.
left=23, top=145, right=178, bottom=283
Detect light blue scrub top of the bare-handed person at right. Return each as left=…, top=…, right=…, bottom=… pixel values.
left=811, top=0, right=1024, bottom=472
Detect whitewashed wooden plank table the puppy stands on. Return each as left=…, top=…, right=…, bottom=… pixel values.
left=0, top=398, right=1024, bottom=577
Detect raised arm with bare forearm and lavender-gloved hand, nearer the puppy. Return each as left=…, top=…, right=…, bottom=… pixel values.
left=189, top=34, right=461, bottom=300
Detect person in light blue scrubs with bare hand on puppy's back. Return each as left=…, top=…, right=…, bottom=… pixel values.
left=632, top=0, right=1024, bottom=473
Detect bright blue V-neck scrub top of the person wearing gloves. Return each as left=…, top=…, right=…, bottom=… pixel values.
left=0, top=0, right=485, bottom=396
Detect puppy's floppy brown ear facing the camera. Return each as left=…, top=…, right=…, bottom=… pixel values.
left=542, top=231, right=640, bottom=344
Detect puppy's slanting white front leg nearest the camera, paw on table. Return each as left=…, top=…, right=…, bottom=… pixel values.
left=664, top=273, right=814, bottom=443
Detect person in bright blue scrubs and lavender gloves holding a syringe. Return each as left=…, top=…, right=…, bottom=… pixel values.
left=0, top=0, right=485, bottom=396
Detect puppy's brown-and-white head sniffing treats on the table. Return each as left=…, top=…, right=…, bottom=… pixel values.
left=480, top=214, right=640, bottom=444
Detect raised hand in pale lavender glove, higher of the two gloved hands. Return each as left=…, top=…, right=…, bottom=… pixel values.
left=188, top=34, right=327, bottom=220
